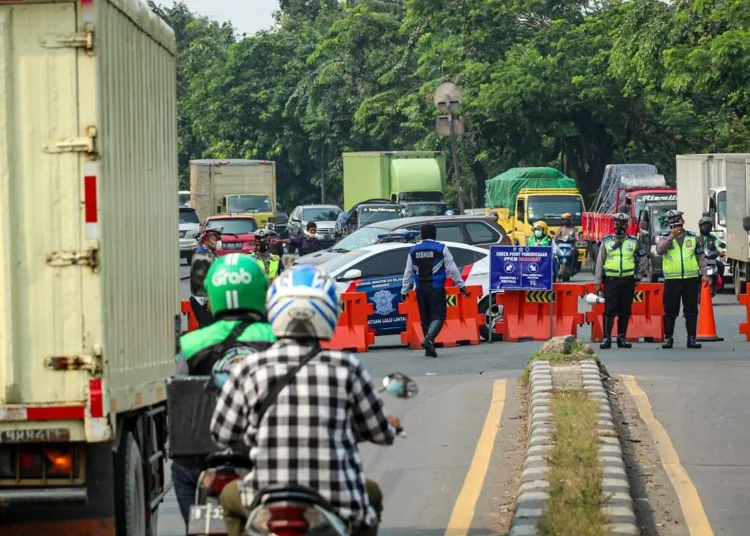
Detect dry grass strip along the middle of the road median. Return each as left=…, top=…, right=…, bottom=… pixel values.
left=539, top=390, right=606, bottom=536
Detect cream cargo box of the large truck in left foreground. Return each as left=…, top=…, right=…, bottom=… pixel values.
left=0, top=0, right=179, bottom=441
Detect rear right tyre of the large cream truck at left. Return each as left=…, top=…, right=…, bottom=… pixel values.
left=115, top=432, right=146, bottom=536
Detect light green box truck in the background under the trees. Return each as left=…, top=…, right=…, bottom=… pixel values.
left=342, top=151, right=445, bottom=210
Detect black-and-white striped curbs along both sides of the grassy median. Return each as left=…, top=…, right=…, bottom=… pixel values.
left=508, top=359, right=640, bottom=536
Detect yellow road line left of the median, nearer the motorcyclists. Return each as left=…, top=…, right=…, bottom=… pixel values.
left=445, top=380, right=507, bottom=536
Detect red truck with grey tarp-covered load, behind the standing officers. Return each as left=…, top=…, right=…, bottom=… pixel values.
left=581, top=164, right=677, bottom=263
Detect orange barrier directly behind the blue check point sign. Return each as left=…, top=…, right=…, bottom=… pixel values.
left=495, top=283, right=587, bottom=342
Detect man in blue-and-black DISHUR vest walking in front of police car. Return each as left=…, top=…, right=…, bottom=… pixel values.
left=401, top=223, right=469, bottom=357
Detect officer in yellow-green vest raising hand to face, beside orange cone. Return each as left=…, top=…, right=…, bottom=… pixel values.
left=656, top=210, right=711, bottom=349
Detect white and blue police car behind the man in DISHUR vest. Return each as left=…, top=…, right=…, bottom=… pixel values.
left=319, top=242, right=497, bottom=340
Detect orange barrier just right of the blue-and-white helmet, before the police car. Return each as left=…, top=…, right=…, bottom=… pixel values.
left=321, top=292, right=375, bottom=353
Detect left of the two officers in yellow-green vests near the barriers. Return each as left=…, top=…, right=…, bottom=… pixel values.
left=594, top=212, right=648, bottom=350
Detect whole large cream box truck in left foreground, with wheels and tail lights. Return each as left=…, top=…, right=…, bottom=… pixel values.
left=0, top=0, right=180, bottom=536
